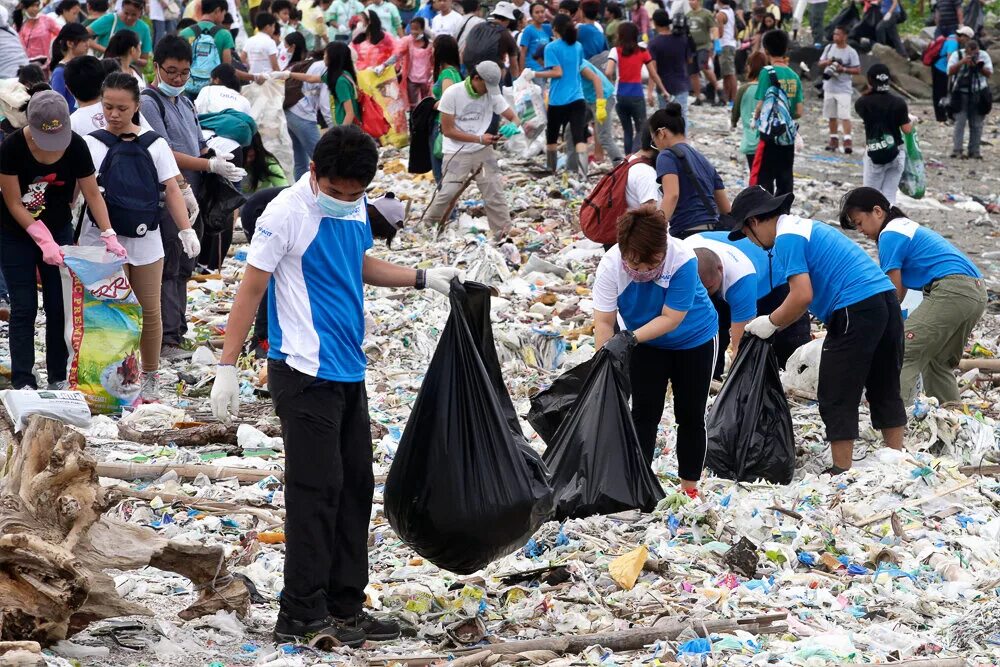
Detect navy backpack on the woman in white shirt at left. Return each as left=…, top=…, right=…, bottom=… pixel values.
left=90, top=130, right=166, bottom=238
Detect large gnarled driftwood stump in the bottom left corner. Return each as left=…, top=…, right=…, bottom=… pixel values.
left=0, top=416, right=249, bottom=645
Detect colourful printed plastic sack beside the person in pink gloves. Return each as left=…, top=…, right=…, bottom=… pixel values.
left=60, top=246, right=142, bottom=413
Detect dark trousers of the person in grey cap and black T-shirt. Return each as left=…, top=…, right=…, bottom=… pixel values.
left=0, top=225, right=73, bottom=389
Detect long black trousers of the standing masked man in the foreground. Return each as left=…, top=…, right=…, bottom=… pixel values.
left=267, top=359, right=375, bottom=621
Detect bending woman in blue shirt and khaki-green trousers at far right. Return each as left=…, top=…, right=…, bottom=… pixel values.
left=840, top=188, right=987, bottom=404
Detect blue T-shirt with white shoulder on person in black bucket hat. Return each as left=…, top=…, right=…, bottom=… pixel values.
left=773, top=215, right=895, bottom=324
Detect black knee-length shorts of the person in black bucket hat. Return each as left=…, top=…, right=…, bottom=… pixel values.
left=817, top=291, right=906, bottom=441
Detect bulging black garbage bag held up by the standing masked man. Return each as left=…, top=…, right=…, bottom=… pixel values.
left=384, top=279, right=553, bottom=574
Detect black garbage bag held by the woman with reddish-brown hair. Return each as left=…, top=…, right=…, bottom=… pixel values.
left=545, top=350, right=663, bottom=521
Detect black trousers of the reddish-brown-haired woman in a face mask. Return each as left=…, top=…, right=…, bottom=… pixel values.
left=629, top=338, right=719, bottom=482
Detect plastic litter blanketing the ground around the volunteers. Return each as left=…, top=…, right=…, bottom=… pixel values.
left=0, top=100, right=1000, bottom=667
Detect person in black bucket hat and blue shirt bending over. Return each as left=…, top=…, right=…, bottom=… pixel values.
left=729, top=186, right=906, bottom=474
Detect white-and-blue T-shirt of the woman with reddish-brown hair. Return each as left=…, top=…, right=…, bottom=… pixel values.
left=593, top=243, right=719, bottom=350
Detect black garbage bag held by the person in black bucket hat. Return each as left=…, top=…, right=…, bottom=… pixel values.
left=705, top=335, right=795, bottom=484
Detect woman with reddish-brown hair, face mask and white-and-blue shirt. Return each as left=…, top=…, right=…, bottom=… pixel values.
left=593, top=204, right=719, bottom=497
